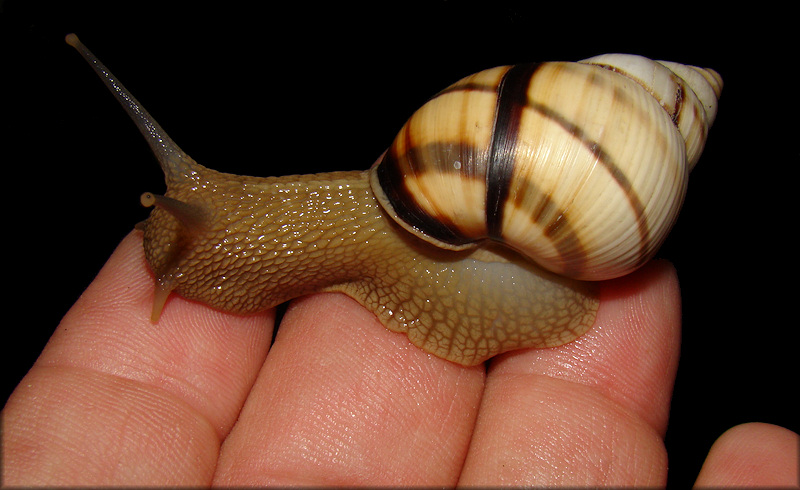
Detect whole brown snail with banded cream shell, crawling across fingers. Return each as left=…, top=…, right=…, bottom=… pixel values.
left=67, top=34, right=722, bottom=365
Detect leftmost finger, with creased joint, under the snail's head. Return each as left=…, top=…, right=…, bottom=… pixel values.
left=3, top=233, right=271, bottom=485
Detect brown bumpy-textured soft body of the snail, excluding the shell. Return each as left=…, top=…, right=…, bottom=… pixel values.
left=67, top=35, right=718, bottom=365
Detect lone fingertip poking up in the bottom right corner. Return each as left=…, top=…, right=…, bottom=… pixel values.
left=695, top=423, right=800, bottom=488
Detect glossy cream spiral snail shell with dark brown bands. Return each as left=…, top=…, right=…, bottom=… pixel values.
left=371, top=55, right=721, bottom=280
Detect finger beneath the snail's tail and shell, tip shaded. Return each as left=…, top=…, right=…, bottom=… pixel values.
left=460, top=263, right=680, bottom=486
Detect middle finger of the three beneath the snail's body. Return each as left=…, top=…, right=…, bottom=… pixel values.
left=216, top=294, right=484, bottom=486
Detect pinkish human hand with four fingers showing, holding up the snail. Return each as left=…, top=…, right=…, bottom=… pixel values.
left=2, top=232, right=799, bottom=486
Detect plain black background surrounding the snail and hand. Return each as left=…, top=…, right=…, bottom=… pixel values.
left=0, top=0, right=800, bottom=487
